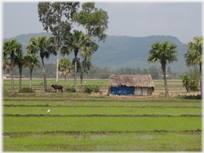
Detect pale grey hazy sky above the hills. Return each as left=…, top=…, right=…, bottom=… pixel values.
left=1, top=1, right=202, bottom=43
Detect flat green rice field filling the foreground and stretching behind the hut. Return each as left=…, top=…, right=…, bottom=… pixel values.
left=2, top=80, right=202, bottom=151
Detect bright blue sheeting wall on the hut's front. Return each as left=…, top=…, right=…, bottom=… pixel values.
left=111, top=86, right=134, bottom=95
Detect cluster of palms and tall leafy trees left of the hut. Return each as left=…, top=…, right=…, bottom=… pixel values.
left=3, top=2, right=109, bottom=94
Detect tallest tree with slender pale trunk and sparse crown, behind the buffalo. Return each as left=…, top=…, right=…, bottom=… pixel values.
left=38, top=2, right=79, bottom=85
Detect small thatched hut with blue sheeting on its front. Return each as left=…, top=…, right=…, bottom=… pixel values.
left=108, top=75, right=155, bottom=96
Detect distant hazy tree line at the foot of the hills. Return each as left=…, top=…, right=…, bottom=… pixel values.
left=3, top=64, right=178, bottom=79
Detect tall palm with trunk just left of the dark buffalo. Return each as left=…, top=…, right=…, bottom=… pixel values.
left=26, top=35, right=56, bottom=92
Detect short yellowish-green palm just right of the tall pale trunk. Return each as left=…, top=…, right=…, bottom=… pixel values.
left=58, top=57, right=73, bottom=86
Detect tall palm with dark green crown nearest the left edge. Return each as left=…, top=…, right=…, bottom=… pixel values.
left=3, top=39, right=22, bottom=94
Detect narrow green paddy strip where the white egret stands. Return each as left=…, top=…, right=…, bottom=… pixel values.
left=3, top=106, right=202, bottom=116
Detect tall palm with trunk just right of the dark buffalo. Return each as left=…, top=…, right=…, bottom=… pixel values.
left=61, top=30, right=92, bottom=92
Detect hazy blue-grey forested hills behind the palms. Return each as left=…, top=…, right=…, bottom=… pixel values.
left=4, top=33, right=188, bottom=73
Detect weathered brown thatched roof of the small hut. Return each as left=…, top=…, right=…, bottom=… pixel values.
left=108, top=75, right=155, bottom=88
